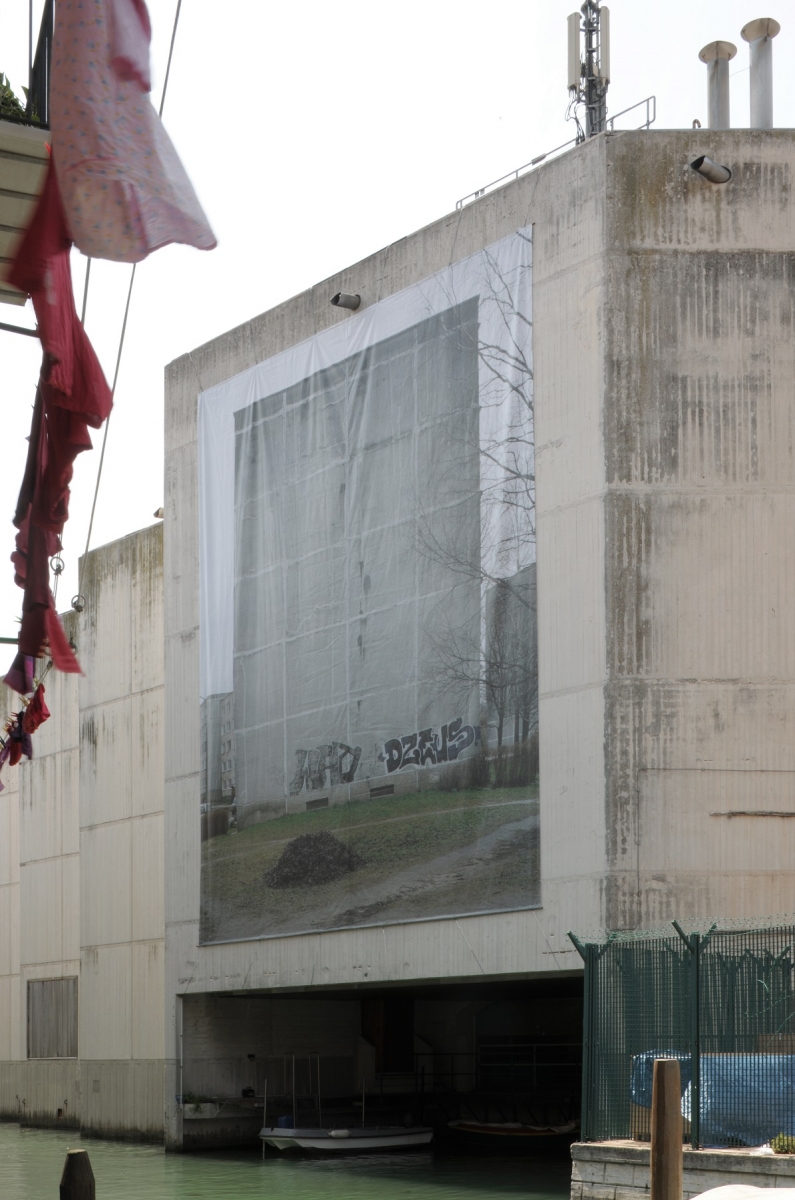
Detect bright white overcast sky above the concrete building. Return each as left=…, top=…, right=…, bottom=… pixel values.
left=0, top=0, right=795, bottom=671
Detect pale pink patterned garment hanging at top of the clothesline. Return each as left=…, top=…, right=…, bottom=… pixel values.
left=50, top=0, right=216, bottom=263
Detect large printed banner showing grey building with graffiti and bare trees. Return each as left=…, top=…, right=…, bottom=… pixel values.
left=197, top=229, right=540, bottom=942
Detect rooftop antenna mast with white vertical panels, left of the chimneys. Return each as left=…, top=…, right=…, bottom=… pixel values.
left=568, top=0, right=610, bottom=142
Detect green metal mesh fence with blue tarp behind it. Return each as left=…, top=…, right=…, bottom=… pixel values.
left=569, top=922, right=795, bottom=1147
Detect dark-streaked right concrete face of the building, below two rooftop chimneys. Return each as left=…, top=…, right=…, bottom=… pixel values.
left=605, top=130, right=795, bottom=928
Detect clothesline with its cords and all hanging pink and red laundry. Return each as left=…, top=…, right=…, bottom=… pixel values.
left=0, top=0, right=215, bottom=790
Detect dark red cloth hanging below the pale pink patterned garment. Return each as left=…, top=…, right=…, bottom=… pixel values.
left=5, top=158, right=113, bottom=691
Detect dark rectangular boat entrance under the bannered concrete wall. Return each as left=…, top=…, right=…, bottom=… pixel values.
left=183, top=976, right=582, bottom=1156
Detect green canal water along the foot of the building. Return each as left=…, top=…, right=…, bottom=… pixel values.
left=0, top=1124, right=570, bottom=1200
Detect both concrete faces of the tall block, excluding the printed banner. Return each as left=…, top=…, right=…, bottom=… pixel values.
left=156, top=131, right=795, bottom=1144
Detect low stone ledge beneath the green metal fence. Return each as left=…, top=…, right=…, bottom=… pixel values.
left=572, top=1141, right=795, bottom=1200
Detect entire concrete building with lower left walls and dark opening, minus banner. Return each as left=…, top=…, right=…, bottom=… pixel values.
left=0, top=130, right=795, bottom=1148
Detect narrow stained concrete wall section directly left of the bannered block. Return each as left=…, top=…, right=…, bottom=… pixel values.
left=78, top=526, right=163, bottom=1139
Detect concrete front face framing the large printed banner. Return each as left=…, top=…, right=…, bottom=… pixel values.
left=165, top=129, right=605, bottom=1145
